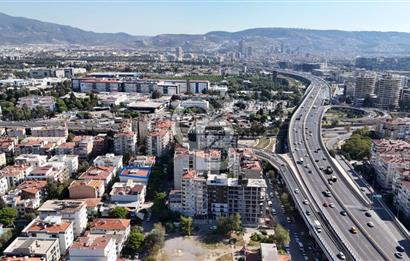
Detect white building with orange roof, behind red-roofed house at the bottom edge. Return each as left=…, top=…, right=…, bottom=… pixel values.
left=89, top=218, right=131, bottom=253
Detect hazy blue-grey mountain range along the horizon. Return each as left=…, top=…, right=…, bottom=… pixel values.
left=0, top=13, right=410, bottom=55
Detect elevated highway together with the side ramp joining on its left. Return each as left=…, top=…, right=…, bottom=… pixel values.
left=258, top=72, right=410, bottom=260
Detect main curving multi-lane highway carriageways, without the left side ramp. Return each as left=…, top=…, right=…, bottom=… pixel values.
left=289, top=70, right=410, bottom=260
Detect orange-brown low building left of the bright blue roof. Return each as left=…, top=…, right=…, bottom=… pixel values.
left=68, top=179, right=105, bottom=199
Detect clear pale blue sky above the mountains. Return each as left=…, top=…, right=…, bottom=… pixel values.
left=0, top=0, right=410, bottom=35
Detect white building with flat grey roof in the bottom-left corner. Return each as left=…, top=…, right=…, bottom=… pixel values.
left=3, top=237, right=61, bottom=261
